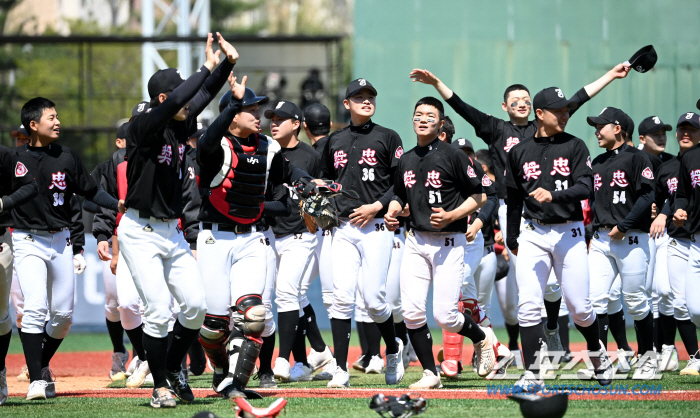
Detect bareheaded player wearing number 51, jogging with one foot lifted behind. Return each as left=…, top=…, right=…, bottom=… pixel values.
left=384, top=97, right=506, bottom=389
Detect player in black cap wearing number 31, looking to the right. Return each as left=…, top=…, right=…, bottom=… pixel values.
left=506, top=87, right=613, bottom=391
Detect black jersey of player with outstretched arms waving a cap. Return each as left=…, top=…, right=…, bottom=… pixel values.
left=447, top=89, right=591, bottom=199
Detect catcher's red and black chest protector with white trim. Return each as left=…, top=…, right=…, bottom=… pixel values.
left=209, top=135, right=280, bottom=225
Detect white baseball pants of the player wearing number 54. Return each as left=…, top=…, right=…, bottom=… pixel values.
left=588, top=230, right=650, bottom=321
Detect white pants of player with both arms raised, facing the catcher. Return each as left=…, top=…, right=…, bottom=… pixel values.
left=118, top=209, right=207, bottom=338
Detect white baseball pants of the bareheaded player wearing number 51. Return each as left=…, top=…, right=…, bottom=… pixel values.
left=401, top=231, right=467, bottom=332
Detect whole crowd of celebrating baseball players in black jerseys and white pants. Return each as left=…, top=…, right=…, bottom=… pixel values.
left=0, top=34, right=700, bottom=407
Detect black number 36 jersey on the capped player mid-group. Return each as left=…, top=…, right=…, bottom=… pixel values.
left=321, top=121, right=402, bottom=218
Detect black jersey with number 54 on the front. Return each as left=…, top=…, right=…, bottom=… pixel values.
left=591, top=144, right=660, bottom=232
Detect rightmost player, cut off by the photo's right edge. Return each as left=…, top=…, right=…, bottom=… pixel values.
left=651, top=112, right=700, bottom=376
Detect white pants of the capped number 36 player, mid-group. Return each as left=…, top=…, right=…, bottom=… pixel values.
left=330, top=218, right=394, bottom=323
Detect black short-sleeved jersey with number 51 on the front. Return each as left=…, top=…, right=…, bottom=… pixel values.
left=394, top=139, right=483, bottom=233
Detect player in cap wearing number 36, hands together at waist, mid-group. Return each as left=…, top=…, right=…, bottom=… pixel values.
left=321, top=78, right=404, bottom=388
